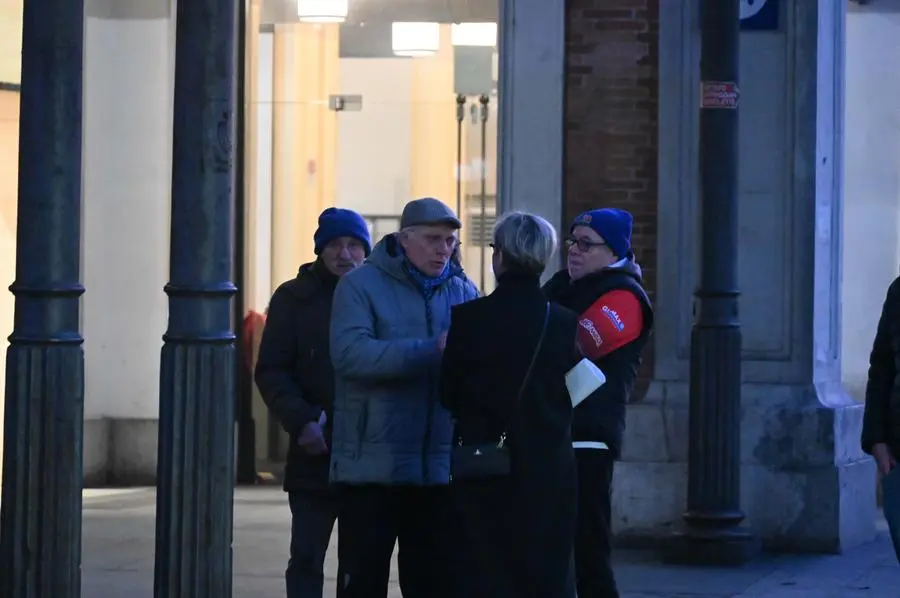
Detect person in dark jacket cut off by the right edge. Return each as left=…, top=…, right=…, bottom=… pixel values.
left=862, top=278, right=900, bottom=560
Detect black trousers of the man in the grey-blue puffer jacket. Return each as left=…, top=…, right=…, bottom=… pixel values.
left=337, top=485, right=458, bottom=598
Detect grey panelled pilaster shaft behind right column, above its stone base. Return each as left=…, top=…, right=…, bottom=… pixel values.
left=655, top=0, right=846, bottom=390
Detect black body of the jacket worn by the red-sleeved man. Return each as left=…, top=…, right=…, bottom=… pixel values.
left=544, top=260, right=653, bottom=458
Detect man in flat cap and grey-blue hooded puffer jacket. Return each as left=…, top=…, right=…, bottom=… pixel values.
left=331, top=198, right=478, bottom=598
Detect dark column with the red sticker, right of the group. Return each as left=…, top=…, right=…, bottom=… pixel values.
left=684, top=0, right=753, bottom=562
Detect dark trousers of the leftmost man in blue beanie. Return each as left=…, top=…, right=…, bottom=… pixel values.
left=284, top=490, right=339, bottom=598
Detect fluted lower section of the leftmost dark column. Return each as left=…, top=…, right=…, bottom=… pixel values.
left=0, top=344, right=84, bottom=598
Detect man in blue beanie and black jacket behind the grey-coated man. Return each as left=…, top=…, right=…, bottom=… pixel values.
left=255, top=208, right=372, bottom=598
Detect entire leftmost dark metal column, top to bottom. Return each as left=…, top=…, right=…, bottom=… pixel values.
left=0, top=0, right=84, bottom=598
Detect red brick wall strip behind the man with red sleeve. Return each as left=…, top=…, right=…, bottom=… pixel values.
left=564, top=0, right=660, bottom=396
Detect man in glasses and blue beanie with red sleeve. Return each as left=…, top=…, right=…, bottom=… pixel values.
left=544, top=208, right=653, bottom=598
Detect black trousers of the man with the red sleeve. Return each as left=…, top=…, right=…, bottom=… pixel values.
left=575, top=449, right=619, bottom=598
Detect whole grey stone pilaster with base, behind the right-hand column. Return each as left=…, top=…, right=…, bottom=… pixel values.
left=614, top=0, right=875, bottom=552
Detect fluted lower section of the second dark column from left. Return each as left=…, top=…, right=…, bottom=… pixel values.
left=154, top=341, right=235, bottom=598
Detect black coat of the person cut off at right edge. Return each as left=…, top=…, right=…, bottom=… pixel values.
left=862, top=278, right=900, bottom=459
